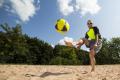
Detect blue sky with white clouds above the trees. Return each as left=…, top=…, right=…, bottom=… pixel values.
left=0, top=0, right=120, bottom=48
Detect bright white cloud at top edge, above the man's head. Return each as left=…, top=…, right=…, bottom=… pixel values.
left=75, top=0, right=101, bottom=15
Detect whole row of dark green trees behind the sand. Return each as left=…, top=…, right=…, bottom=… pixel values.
left=0, top=23, right=120, bottom=65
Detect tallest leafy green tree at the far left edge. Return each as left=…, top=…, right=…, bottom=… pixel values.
left=0, top=24, right=28, bottom=63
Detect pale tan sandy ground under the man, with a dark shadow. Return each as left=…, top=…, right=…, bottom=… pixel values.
left=0, top=65, right=120, bottom=80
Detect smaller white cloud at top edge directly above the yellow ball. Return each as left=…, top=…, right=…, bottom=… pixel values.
left=58, top=0, right=74, bottom=15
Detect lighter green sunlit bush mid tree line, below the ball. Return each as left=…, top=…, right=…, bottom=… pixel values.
left=50, top=45, right=80, bottom=65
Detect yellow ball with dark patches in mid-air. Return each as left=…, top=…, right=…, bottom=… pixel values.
left=55, top=19, right=70, bottom=33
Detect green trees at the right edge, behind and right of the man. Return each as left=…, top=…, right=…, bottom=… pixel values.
left=96, top=38, right=120, bottom=64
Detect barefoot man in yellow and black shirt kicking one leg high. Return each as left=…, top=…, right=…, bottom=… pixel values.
left=65, top=20, right=102, bottom=72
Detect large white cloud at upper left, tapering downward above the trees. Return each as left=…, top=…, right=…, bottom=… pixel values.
left=10, top=0, right=37, bottom=22
